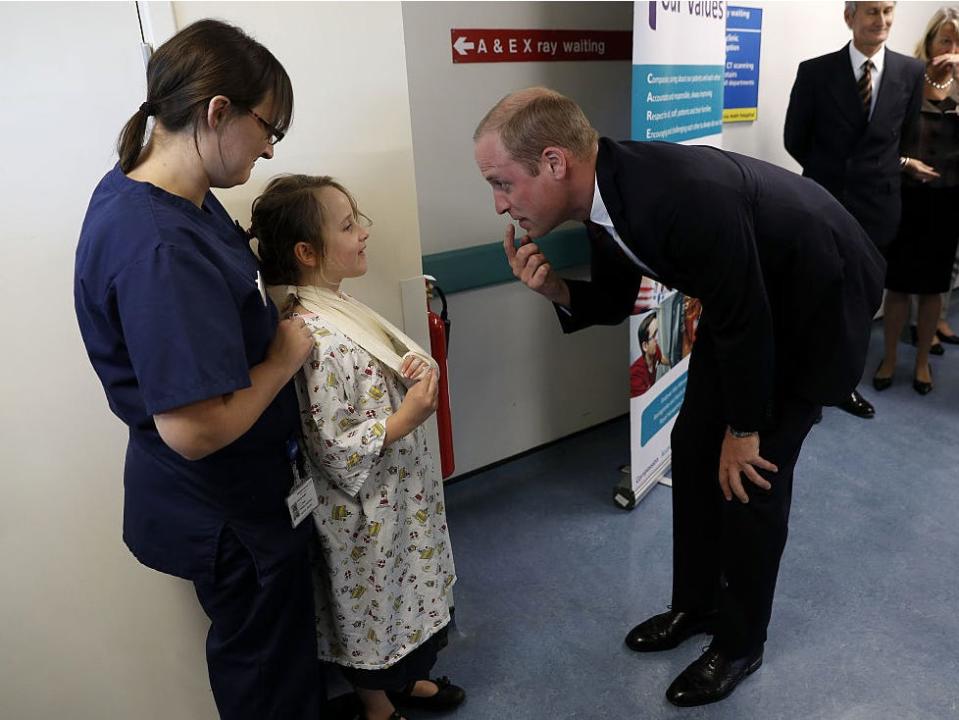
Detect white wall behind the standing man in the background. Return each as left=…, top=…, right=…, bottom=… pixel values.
left=723, top=0, right=943, bottom=166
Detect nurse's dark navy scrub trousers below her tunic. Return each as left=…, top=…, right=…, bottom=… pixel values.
left=194, top=520, right=326, bottom=720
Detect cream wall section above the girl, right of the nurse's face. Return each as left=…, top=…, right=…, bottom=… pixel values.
left=174, top=2, right=426, bottom=334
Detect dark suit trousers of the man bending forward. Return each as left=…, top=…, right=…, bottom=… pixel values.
left=671, top=322, right=820, bottom=657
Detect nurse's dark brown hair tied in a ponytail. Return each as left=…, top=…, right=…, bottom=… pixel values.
left=117, top=20, right=293, bottom=173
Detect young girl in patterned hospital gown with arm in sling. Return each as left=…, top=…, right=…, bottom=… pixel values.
left=251, top=175, right=465, bottom=720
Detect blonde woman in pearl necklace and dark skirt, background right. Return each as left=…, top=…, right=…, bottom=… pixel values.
left=872, top=8, right=959, bottom=395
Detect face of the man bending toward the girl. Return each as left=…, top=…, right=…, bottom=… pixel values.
left=473, top=132, right=569, bottom=238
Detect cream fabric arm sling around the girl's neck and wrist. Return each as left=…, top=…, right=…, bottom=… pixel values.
left=271, top=285, right=438, bottom=386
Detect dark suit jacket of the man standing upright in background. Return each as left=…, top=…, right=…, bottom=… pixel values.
left=784, top=45, right=923, bottom=247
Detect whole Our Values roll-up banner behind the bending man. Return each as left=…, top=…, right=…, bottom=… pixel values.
left=628, top=0, right=726, bottom=506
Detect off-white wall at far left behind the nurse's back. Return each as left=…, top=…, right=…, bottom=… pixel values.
left=0, top=3, right=218, bottom=720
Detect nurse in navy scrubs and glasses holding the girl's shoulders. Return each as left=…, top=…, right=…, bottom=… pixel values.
left=74, top=20, right=324, bottom=720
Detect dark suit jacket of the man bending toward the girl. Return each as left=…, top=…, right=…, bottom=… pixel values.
left=558, top=138, right=885, bottom=430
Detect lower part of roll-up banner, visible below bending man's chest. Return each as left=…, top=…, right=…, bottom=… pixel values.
left=629, top=278, right=702, bottom=497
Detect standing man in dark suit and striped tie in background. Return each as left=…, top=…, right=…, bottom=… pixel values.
left=784, top=2, right=923, bottom=418
